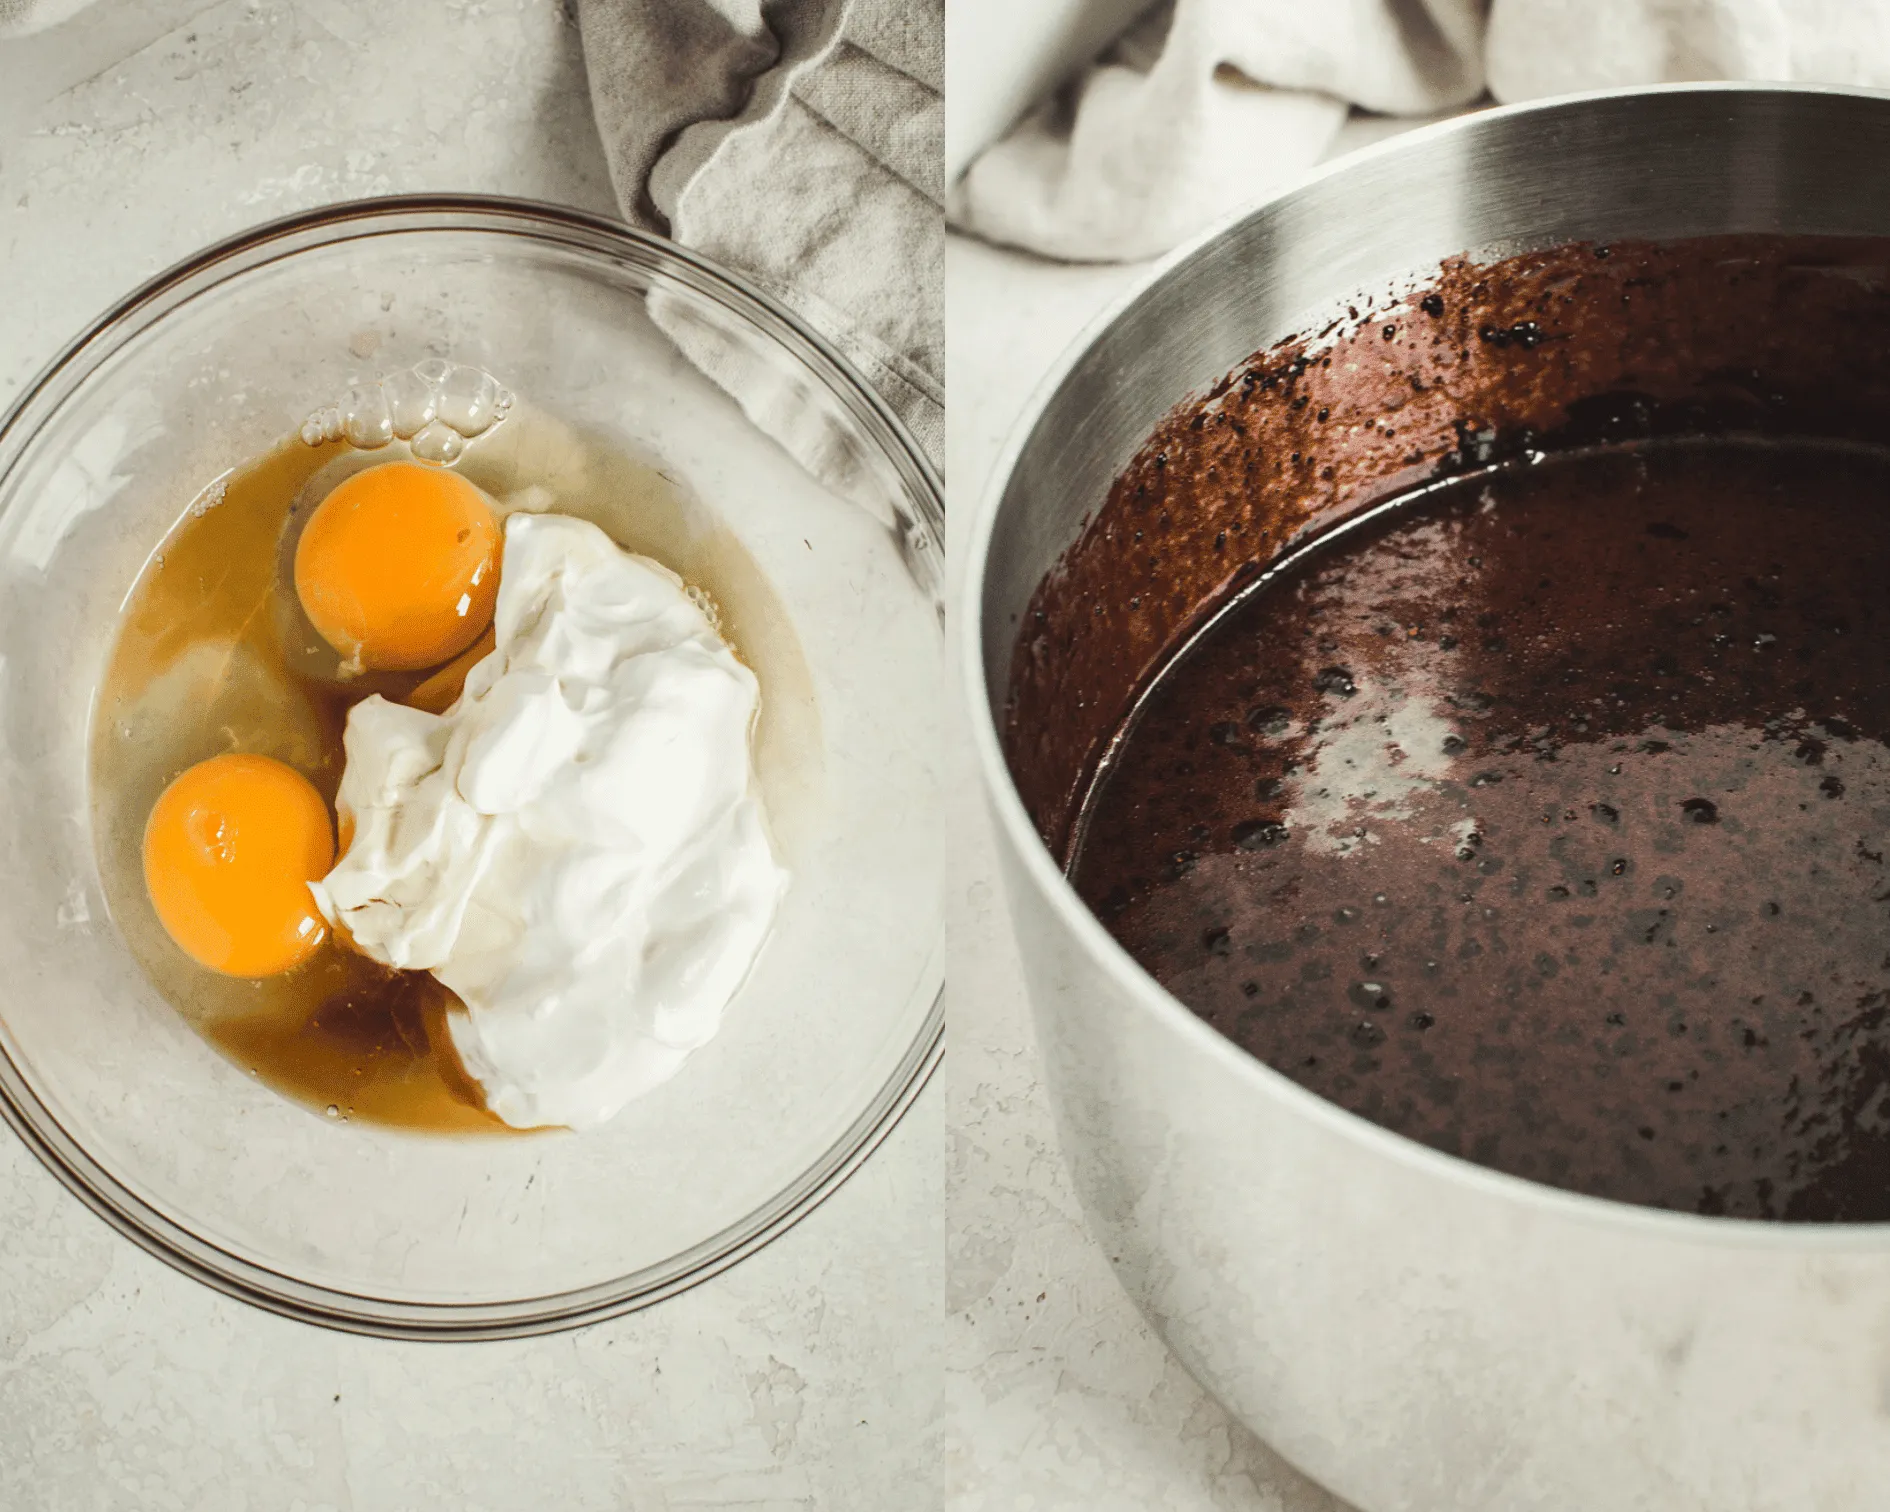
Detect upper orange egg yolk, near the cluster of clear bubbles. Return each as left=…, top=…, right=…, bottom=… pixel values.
left=295, top=461, right=499, bottom=671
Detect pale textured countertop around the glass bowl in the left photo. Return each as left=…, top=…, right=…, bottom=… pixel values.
left=0, top=0, right=945, bottom=1512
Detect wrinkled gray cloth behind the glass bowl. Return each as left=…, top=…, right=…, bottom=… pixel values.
left=578, top=0, right=945, bottom=488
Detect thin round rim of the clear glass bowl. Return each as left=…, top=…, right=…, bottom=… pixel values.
left=0, top=195, right=945, bottom=1342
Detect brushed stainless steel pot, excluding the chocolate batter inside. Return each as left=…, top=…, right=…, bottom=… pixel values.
left=956, top=87, right=1890, bottom=1512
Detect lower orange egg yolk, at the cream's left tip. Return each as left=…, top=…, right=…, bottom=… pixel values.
left=144, top=756, right=335, bottom=977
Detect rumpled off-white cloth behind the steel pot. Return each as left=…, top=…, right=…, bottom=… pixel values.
left=949, top=0, right=1890, bottom=261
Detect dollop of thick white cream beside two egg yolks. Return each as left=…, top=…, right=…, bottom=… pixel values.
left=314, top=514, right=788, bottom=1128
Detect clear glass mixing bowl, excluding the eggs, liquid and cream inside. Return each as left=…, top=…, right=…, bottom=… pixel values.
left=0, top=197, right=943, bottom=1338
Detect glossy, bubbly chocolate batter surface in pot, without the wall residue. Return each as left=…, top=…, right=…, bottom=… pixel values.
left=1072, top=440, right=1890, bottom=1221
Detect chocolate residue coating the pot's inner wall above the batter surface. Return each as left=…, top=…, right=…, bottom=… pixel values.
left=1005, top=236, right=1890, bottom=860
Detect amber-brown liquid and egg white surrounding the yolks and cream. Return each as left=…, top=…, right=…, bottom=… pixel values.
left=91, top=406, right=818, bottom=1132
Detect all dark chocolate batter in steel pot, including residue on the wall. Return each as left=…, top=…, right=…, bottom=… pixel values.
left=1007, top=238, right=1890, bottom=1221
